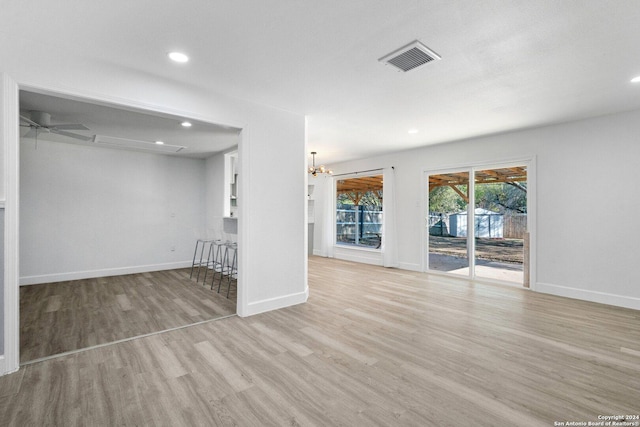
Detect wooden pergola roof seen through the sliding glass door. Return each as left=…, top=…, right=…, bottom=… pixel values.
left=429, top=166, right=527, bottom=203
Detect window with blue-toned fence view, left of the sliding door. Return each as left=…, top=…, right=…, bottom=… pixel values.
left=336, top=175, right=383, bottom=249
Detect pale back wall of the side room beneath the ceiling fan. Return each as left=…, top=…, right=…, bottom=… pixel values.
left=20, top=139, right=206, bottom=284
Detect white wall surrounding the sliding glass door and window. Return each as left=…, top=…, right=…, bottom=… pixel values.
left=316, top=111, right=640, bottom=309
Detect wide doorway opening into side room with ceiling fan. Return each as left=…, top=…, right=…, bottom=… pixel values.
left=19, top=90, right=240, bottom=363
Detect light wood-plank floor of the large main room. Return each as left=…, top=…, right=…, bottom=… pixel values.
left=0, top=257, right=640, bottom=426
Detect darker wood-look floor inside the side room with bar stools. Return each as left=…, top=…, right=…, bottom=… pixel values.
left=20, top=268, right=236, bottom=363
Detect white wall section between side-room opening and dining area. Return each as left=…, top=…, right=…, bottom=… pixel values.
left=238, top=115, right=308, bottom=313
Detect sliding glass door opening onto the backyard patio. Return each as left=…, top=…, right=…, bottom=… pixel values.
left=423, top=163, right=528, bottom=285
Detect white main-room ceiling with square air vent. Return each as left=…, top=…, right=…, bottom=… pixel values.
left=0, top=0, right=640, bottom=165
